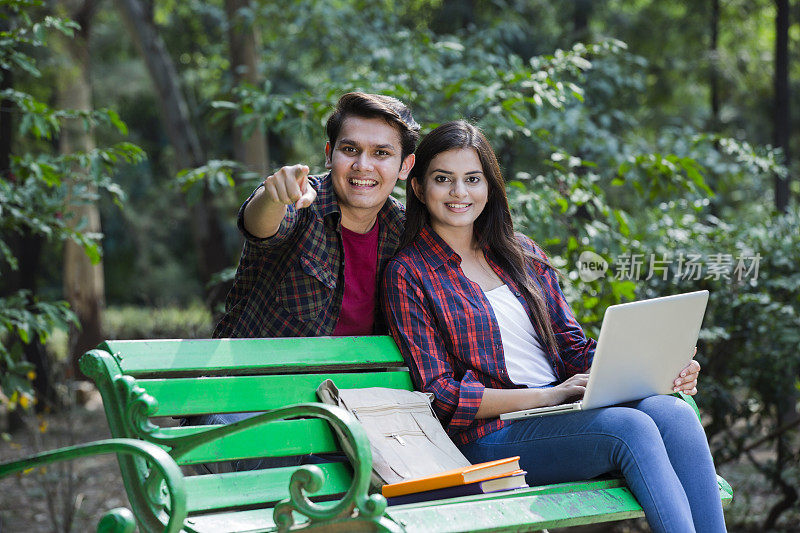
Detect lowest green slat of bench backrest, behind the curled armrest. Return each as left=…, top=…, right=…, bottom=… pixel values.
left=186, top=463, right=352, bottom=513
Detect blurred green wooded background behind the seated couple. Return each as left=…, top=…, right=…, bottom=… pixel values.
left=0, top=0, right=800, bottom=530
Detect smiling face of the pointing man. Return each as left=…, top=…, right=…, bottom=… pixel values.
left=325, top=117, right=414, bottom=220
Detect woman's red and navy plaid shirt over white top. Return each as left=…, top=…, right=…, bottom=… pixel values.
left=383, top=226, right=596, bottom=444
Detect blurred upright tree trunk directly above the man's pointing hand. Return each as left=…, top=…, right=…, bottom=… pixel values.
left=225, top=0, right=269, bottom=175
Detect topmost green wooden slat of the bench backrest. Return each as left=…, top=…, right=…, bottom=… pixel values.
left=100, top=337, right=404, bottom=376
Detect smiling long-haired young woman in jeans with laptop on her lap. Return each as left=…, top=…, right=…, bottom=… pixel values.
left=384, top=121, right=725, bottom=532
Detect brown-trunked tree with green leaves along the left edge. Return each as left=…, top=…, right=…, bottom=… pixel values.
left=0, top=1, right=144, bottom=420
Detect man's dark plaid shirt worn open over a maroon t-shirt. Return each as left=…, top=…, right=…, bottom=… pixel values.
left=214, top=174, right=405, bottom=337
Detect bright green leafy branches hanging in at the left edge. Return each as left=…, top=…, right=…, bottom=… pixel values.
left=0, top=0, right=144, bottom=405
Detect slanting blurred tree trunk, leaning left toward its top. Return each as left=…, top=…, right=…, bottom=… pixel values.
left=115, top=0, right=229, bottom=309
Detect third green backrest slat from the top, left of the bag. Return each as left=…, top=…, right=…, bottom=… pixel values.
left=163, top=419, right=339, bottom=465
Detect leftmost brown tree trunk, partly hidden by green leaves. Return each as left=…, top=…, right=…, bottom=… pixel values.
left=58, top=0, right=105, bottom=377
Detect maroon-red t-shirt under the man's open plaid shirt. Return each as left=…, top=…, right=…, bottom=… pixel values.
left=333, top=221, right=378, bottom=337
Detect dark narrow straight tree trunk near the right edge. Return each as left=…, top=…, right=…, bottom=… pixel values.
left=774, top=0, right=790, bottom=213
